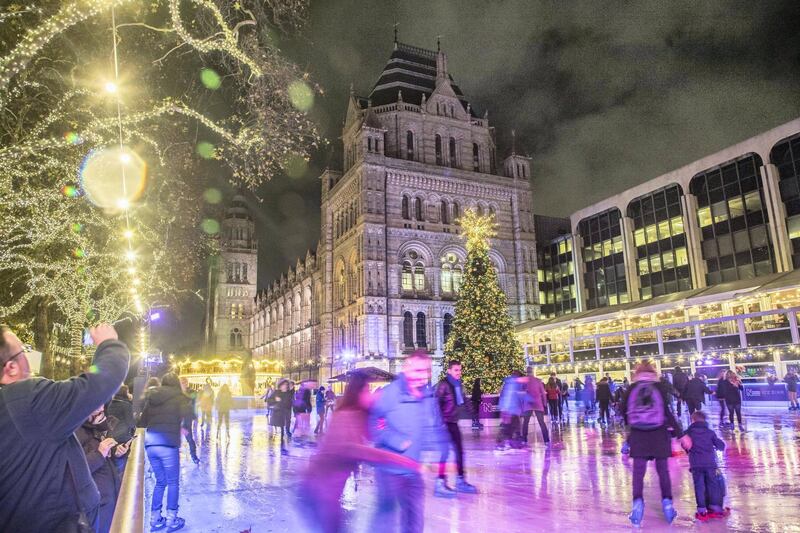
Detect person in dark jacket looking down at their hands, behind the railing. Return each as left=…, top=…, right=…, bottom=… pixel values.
left=75, top=405, right=130, bottom=533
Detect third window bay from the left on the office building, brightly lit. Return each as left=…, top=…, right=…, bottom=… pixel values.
left=628, top=185, right=692, bottom=300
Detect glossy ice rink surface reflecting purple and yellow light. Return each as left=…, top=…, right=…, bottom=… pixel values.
left=148, top=407, right=800, bottom=533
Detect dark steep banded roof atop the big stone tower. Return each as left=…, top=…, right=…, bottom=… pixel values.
left=365, top=43, right=474, bottom=115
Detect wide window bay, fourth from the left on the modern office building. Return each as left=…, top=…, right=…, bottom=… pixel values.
left=689, top=154, right=775, bottom=285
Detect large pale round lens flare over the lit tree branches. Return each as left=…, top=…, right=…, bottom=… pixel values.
left=80, top=146, right=147, bottom=212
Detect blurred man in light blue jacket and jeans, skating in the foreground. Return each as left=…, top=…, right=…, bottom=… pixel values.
left=368, top=350, right=448, bottom=533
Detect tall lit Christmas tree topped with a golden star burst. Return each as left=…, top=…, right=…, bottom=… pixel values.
left=444, top=210, right=524, bottom=392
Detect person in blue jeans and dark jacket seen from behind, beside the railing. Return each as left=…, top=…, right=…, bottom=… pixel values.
left=139, top=374, right=192, bottom=531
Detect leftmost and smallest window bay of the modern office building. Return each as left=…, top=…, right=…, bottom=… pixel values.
left=539, top=237, right=578, bottom=318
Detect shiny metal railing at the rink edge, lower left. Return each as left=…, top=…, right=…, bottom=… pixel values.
left=110, top=428, right=145, bottom=533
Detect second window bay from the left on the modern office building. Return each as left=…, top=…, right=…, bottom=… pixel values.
left=578, top=209, right=628, bottom=309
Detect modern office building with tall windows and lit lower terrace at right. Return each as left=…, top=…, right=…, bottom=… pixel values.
left=517, top=119, right=800, bottom=380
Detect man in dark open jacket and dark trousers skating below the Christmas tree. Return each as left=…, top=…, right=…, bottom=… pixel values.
left=434, top=360, right=478, bottom=498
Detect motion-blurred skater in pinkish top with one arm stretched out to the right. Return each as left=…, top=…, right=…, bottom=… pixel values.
left=298, top=370, right=419, bottom=533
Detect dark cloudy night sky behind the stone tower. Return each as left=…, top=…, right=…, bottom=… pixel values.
left=161, top=0, right=800, bottom=356
